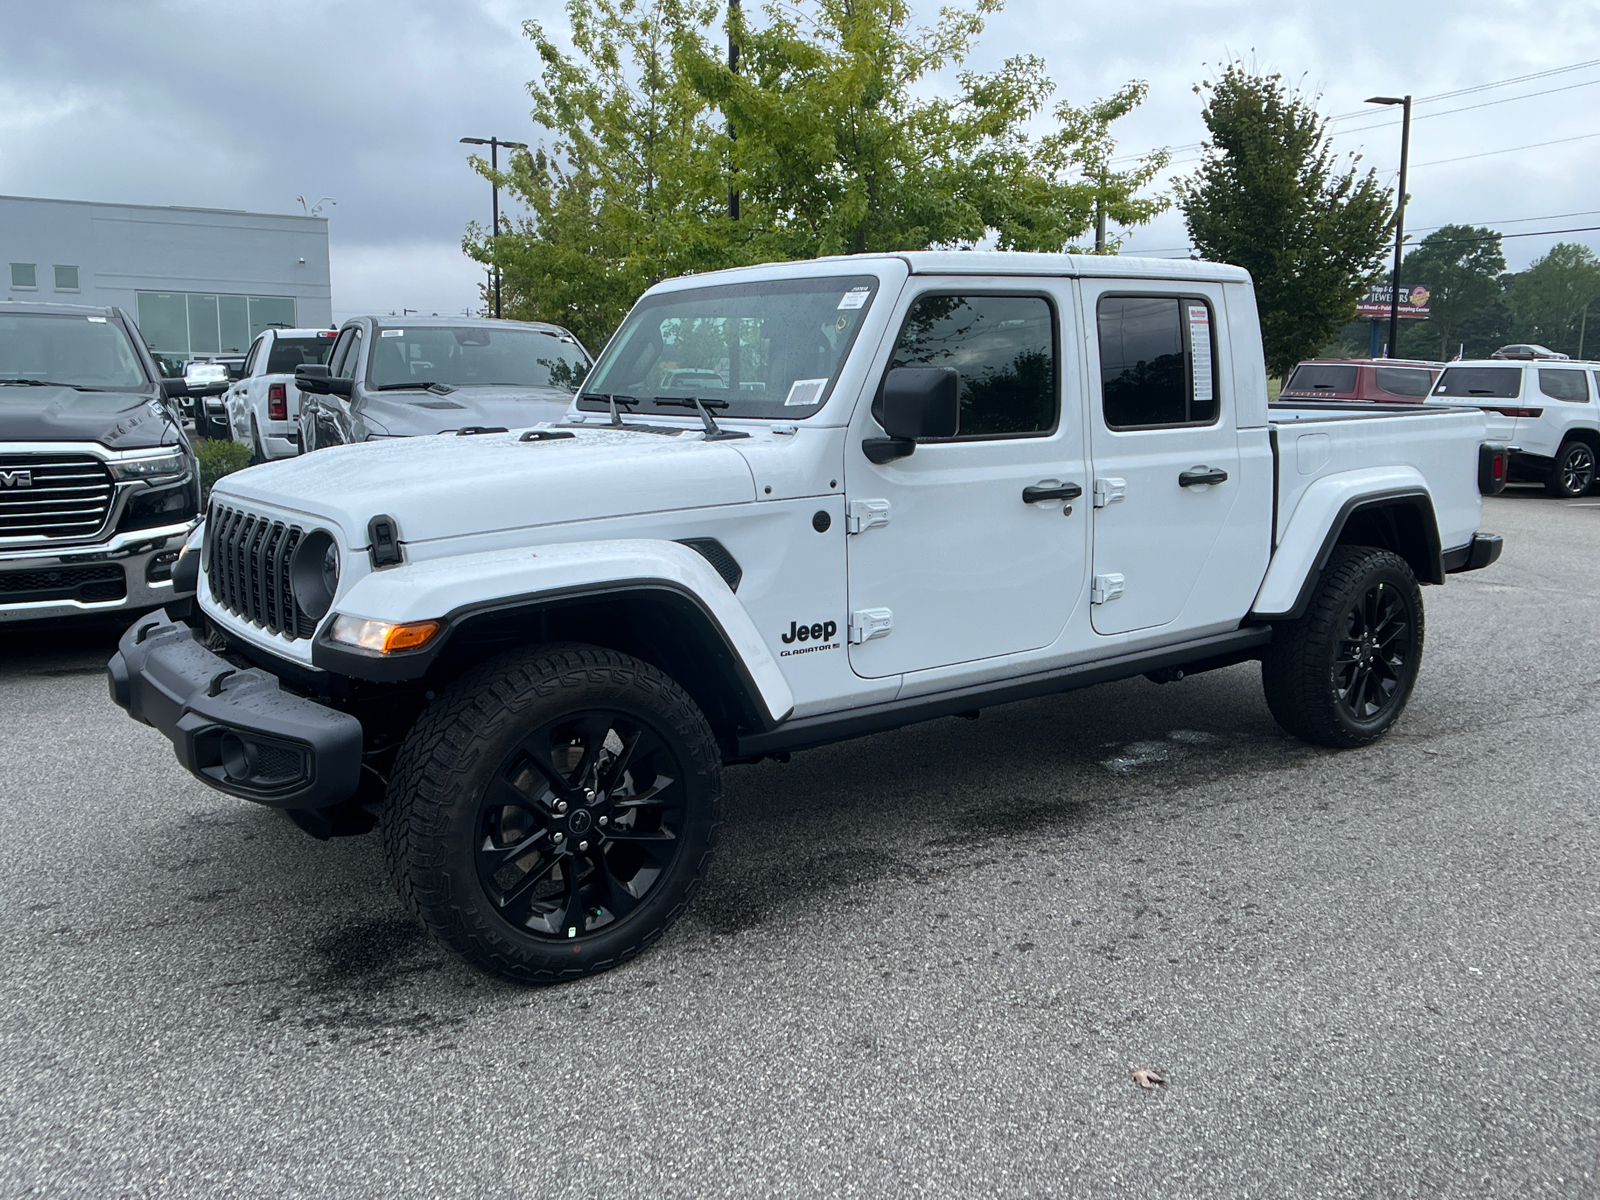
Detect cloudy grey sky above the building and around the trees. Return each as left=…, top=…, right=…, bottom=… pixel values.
left=0, top=0, right=1600, bottom=317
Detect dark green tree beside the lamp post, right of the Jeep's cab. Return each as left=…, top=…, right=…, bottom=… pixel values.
left=1178, top=62, right=1394, bottom=378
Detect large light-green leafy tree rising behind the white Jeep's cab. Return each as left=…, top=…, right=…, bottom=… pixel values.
left=464, top=0, right=1165, bottom=349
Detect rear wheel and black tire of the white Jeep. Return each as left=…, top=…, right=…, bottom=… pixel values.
left=1261, top=546, right=1422, bottom=749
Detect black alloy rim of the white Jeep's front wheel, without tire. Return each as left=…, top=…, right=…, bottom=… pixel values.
left=477, top=710, right=686, bottom=941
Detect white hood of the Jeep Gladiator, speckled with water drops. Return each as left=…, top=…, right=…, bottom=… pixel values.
left=214, top=429, right=755, bottom=549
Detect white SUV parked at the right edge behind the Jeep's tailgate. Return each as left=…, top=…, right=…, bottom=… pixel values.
left=1429, top=358, right=1600, bottom=498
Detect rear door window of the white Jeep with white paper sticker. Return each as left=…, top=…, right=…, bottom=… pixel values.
left=1098, top=296, right=1218, bottom=429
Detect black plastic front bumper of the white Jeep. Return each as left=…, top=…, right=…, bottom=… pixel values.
left=106, top=611, right=362, bottom=808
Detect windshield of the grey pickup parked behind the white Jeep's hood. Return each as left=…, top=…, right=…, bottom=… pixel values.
left=366, top=325, right=589, bottom=392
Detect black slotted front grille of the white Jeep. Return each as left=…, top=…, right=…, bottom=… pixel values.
left=205, top=506, right=317, bottom=638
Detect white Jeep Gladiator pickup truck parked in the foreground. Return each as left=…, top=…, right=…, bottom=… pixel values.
left=109, top=253, right=1504, bottom=981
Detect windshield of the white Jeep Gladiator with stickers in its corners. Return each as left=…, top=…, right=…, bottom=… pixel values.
left=578, top=275, right=878, bottom=419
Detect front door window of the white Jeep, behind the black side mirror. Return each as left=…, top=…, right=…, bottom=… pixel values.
left=890, top=294, right=1058, bottom=440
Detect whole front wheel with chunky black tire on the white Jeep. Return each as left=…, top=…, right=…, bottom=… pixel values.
left=379, top=645, right=722, bottom=982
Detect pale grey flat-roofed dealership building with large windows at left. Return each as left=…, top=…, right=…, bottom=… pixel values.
left=0, top=195, right=333, bottom=362
